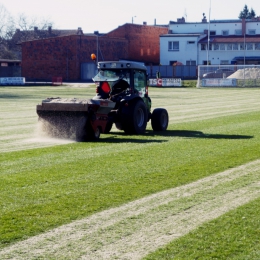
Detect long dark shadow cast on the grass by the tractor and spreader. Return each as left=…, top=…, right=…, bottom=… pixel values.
left=100, top=130, right=254, bottom=143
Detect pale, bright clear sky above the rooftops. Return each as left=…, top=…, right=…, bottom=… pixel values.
left=0, top=0, right=260, bottom=33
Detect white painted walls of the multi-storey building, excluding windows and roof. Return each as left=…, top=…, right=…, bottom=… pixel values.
left=160, top=20, right=260, bottom=65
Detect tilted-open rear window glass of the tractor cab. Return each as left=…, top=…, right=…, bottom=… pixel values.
left=93, top=69, right=130, bottom=84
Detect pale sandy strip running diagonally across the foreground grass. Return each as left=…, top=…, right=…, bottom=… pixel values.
left=0, top=160, right=260, bottom=259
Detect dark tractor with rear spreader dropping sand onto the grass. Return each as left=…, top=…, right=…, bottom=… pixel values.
left=37, top=61, right=169, bottom=141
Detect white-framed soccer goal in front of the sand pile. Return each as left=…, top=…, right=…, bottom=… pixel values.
left=197, top=65, right=260, bottom=88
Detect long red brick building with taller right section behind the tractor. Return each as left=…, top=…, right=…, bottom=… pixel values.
left=21, top=24, right=168, bottom=81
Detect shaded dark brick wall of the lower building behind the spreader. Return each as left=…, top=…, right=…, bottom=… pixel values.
left=22, top=35, right=128, bottom=81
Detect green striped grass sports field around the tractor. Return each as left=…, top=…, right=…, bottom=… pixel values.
left=0, top=86, right=260, bottom=259
